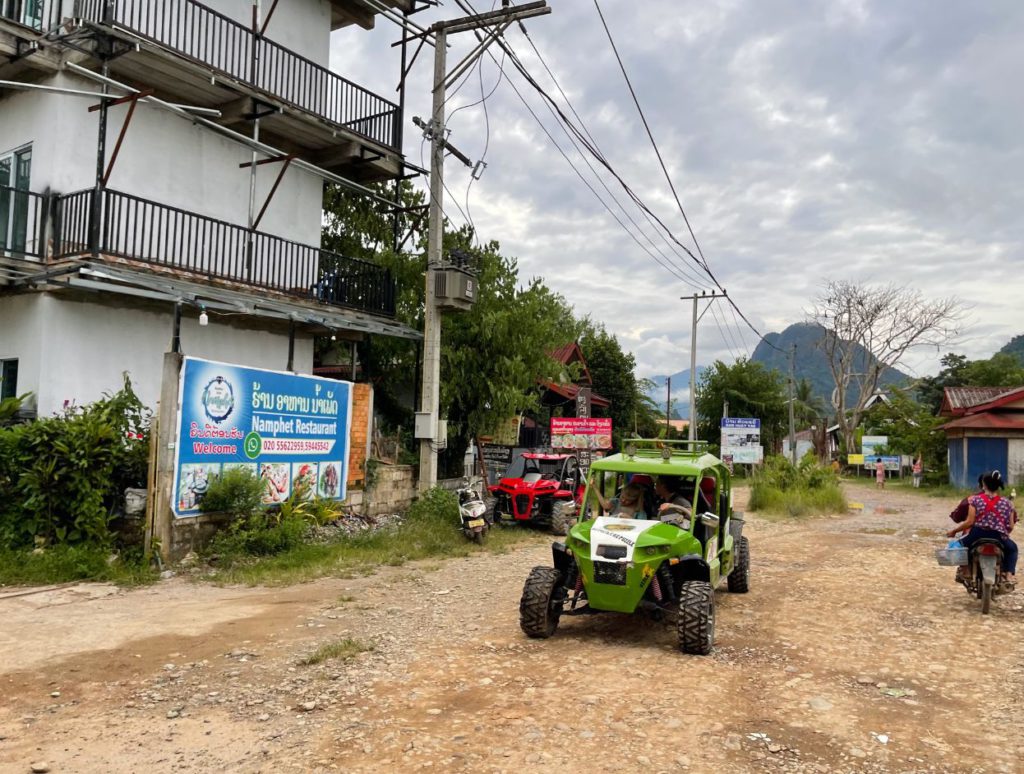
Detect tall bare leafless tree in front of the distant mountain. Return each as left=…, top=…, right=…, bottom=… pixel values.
left=808, top=281, right=963, bottom=454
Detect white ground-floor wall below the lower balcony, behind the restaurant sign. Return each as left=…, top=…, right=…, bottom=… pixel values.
left=0, top=294, right=313, bottom=416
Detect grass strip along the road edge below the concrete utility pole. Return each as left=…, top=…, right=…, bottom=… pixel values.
left=201, top=492, right=539, bottom=586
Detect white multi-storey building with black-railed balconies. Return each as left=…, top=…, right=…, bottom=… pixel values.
left=0, top=0, right=417, bottom=416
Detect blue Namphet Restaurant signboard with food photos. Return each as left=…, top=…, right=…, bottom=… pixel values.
left=173, top=357, right=352, bottom=517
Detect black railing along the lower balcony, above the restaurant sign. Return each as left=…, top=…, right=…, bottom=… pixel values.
left=0, top=186, right=395, bottom=317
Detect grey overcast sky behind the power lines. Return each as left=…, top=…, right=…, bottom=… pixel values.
left=332, top=0, right=1024, bottom=376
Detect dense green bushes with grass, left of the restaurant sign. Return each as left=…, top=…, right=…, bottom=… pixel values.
left=0, top=377, right=156, bottom=586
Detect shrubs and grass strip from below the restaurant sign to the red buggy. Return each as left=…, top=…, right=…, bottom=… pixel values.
left=194, top=484, right=536, bottom=586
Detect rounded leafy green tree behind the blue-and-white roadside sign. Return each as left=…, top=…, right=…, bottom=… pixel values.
left=696, top=357, right=788, bottom=450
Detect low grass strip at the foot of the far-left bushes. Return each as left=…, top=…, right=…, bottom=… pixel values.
left=0, top=546, right=159, bottom=586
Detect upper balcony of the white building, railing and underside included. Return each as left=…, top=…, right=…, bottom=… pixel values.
left=69, top=0, right=401, bottom=180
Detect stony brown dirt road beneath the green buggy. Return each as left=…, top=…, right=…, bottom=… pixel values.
left=0, top=484, right=1024, bottom=772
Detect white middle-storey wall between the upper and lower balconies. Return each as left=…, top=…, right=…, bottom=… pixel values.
left=0, top=75, right=323, bottom=246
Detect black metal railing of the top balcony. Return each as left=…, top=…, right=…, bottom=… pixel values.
left=74, top=0, right=401, bottom=149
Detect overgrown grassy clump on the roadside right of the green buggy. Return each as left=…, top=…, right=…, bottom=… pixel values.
left=748, top=455, right=847, bottom=517
